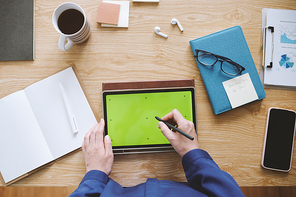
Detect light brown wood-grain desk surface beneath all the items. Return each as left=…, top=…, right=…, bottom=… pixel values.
left=0, top=0, right=296, bottom=186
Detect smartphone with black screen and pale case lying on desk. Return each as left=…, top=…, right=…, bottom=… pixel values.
left=261, top=108, right=296, bottom=172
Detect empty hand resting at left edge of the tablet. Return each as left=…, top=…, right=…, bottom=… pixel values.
left=82, top=119, right=114, bottom=175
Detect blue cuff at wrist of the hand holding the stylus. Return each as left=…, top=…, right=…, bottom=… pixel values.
left=182, top=149, right=213, bottom=171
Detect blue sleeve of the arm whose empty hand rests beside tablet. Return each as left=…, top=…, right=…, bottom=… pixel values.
left=69, top=170, right=109, bottom=197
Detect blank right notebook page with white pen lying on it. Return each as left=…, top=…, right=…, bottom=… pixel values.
left=25, top=67, right=97, bottom=158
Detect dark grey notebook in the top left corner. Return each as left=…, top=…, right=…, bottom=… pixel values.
left=0, top=0, right=34, bottom=61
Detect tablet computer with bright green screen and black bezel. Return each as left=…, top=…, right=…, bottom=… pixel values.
left=103, top=87, right=196, bottom=154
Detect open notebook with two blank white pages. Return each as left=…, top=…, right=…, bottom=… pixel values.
left=0, top=67, right=97, bottom=184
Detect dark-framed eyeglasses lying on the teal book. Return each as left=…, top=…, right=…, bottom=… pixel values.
left=194, top=49, right=245, bottom=76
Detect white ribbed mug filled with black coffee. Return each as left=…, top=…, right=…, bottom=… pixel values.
left=52, top=2, right=90, bottom=51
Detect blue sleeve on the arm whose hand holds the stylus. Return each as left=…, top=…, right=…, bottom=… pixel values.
left=182, top=149, right=244, bottom=197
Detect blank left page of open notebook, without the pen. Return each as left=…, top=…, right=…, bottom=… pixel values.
left=0, top=91, right=53, bottom=183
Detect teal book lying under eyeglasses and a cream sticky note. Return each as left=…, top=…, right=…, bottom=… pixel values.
left=189, top=26, right=266, bottom=115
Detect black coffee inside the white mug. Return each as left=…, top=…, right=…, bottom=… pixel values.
left=58, top=9, right=84, bottom=34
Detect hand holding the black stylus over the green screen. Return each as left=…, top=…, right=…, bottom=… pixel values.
left=158, top=109, right=199, bottom=157
